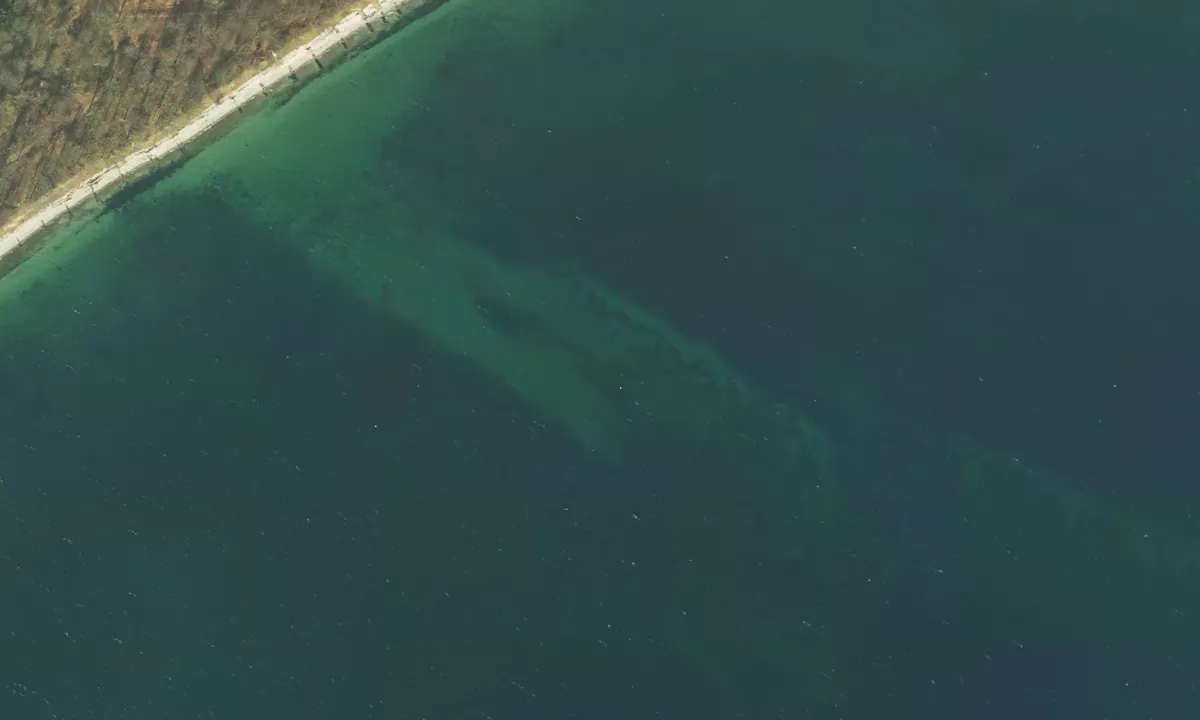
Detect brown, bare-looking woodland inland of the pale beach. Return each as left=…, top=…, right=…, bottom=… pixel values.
left=0, top=0, right=365, bottom=224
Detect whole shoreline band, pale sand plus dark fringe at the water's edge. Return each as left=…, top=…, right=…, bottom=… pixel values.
left=0, top=0, right=442, bottom=280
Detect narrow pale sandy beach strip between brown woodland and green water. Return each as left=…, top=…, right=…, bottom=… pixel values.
left=0, top=0, right=421, bottom=268
